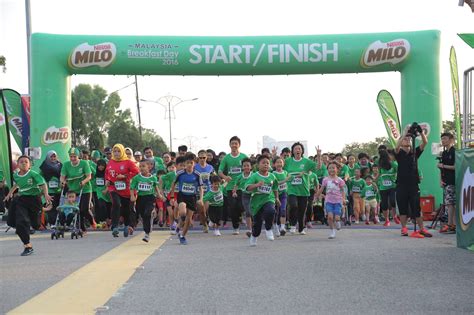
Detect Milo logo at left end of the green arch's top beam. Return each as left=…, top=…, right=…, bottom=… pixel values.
left=69, top=42, right=117, bottom=68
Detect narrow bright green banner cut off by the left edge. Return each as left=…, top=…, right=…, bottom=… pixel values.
left=0, top=90, right=12, bottom=187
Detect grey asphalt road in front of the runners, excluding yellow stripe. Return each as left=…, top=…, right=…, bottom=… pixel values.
left=0, top=226, right=474, bottom=314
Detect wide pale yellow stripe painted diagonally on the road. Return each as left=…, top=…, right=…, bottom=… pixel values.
left=8, top=231, right=169, bottom=314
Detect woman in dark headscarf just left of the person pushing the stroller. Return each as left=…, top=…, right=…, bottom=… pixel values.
left=40, top=150, right=63, bottom=225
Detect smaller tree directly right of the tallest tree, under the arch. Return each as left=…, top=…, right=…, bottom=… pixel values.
left=107, top=109, right=143, bottom=150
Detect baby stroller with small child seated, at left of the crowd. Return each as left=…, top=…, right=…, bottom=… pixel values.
left=51, top=190, right=83, bottom=240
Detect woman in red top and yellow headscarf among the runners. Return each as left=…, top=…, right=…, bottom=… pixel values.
left=105, top=144, right=138, bottom=237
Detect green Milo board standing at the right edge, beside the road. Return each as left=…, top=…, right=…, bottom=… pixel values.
left=455, top=149, right=474, bottom=248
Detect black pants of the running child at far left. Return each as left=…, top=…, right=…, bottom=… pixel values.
left=8, top=196, right=41, bottom=245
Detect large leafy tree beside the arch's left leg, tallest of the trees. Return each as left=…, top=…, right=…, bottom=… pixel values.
left=72, top=84, right=121, bottom=149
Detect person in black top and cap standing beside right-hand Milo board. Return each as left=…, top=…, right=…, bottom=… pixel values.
left=438, top=132, right=456, bottom=234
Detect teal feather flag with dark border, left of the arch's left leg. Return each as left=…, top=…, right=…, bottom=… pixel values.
left=2, top=89, right=24, bottom=152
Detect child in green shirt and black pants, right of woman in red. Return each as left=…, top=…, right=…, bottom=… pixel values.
left=130, top=160, right=158, bottom=243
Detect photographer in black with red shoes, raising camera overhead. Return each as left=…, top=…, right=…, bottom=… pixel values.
left=395, top=123, right=432, bottom=238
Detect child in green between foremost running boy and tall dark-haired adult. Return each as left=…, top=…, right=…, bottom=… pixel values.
left=273, top=157, right=291, bottom=236
